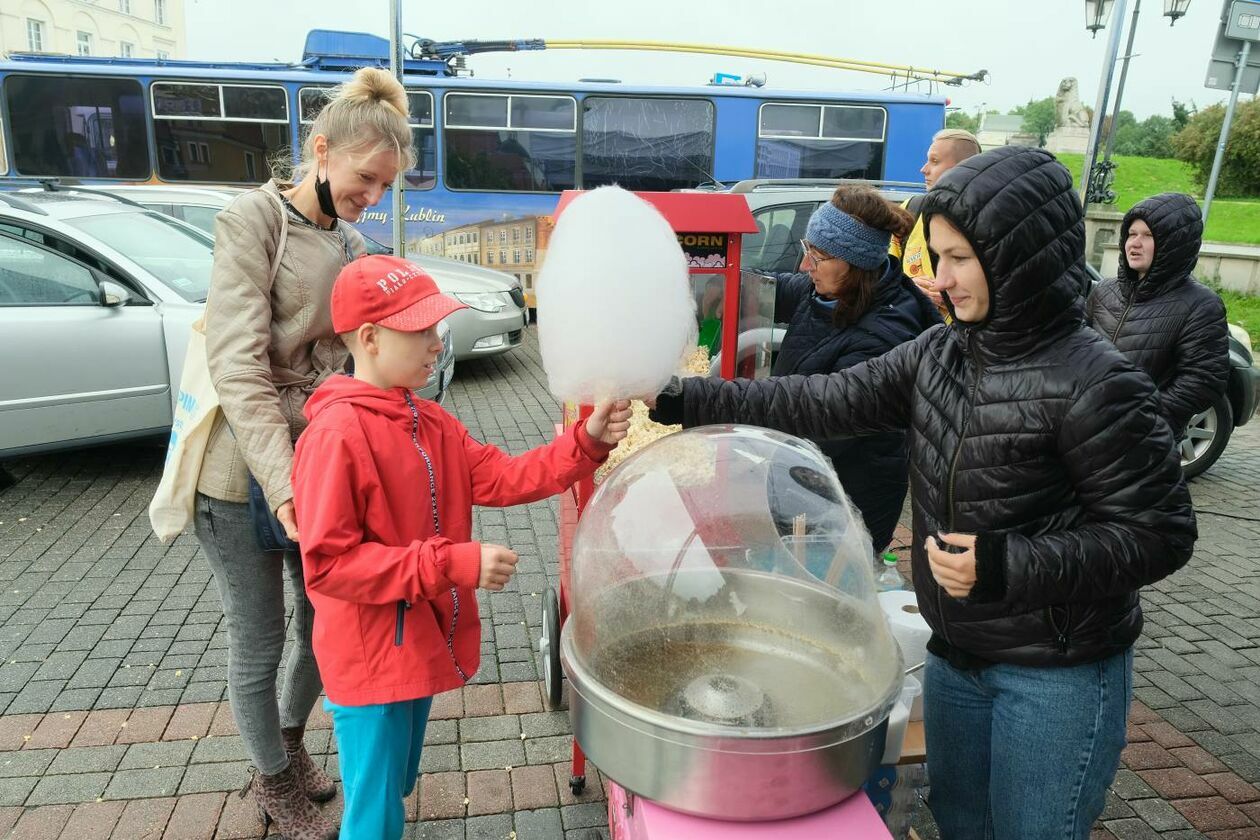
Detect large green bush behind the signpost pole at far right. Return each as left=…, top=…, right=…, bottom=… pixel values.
left=1172, top=99, right=1260, bottom=198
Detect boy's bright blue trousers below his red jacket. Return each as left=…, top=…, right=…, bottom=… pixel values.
left=324, top=698, right=433, bottom=840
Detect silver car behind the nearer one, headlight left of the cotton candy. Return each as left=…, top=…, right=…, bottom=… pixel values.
left=100, top=185, right=529, bottom=361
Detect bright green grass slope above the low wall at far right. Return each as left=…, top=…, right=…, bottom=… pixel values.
left=1058, top=154, right=1260, bottom=244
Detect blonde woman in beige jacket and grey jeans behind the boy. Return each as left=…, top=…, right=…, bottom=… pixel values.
left=195, top=68, right=415, bottom=840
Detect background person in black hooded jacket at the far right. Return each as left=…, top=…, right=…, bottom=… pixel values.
left=1085, top=193, right=1230, bottom=440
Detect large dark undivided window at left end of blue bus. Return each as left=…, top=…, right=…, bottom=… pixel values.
left=4, top=76, right=149, bottom=179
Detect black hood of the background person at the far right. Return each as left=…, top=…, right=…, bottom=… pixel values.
left=1118, top=193, right=1203, bottom=300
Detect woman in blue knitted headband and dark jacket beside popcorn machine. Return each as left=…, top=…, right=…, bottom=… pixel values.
left=772, top=185, right=941, bottom=553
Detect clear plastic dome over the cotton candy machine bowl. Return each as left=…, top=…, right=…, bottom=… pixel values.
left=564, top=426, right=902, bottom=737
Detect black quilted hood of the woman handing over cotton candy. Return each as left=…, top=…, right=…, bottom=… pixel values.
left=922, top=146, right=1089, bottom=359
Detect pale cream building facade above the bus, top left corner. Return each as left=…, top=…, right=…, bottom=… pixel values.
left=0, top=0, right=188, bottom=59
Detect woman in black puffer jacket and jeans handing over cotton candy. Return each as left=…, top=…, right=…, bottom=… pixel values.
left=654, top=146, right=1197, bottom=840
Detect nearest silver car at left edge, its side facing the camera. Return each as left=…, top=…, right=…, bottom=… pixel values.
left=0, top=189, right=454, bottom=460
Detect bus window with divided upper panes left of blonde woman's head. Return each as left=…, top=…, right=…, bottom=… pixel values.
left=150, top=82, right=289, bottom=184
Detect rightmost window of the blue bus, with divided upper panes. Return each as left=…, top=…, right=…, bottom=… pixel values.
left=757, top=102, right=887, bottom=179
